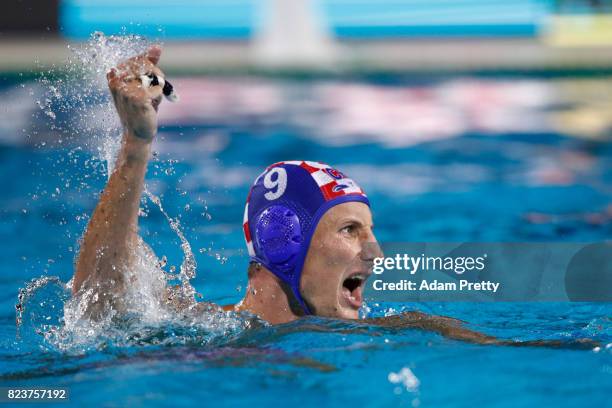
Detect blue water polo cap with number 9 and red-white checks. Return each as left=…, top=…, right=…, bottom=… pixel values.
left=243, top=161, right=370, bottom=314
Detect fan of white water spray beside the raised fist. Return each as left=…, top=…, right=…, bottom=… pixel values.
left=36, top=32, right=151, bottom=167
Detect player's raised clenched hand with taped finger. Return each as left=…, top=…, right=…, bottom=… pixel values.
left=106, top=46, right=164, bottom=141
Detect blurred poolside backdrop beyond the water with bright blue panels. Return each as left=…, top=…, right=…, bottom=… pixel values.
left=0, top=0, right=612, bottom=73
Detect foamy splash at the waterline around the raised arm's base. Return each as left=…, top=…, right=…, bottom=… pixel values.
left=15, top=231, right=251, bottom=354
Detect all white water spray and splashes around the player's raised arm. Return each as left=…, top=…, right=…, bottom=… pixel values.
left=16, top=32, right=251, bottom=352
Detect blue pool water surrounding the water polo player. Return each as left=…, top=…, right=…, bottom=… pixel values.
left=0, top=64, right=612, bottom=407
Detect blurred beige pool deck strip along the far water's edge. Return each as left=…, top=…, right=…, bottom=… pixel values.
left=0, top=38, right=612, bottom=74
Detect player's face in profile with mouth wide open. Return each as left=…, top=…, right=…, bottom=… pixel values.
left=300, top=202, right=381, bottom=319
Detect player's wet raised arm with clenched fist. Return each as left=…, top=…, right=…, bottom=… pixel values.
left=72, top=47, right=163, bottom=294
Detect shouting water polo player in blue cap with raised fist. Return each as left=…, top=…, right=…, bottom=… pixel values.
left=72, top=47, right=592, bottom=345
